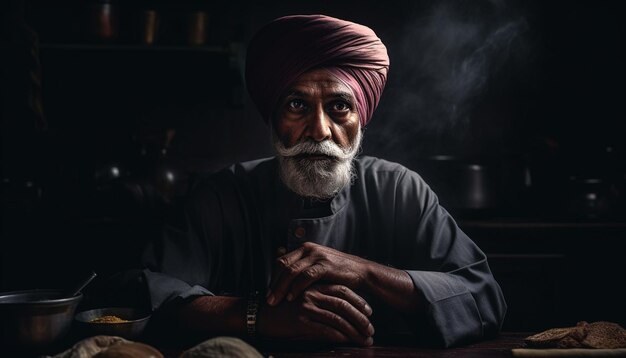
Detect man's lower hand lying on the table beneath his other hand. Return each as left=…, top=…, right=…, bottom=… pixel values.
left=257, top=284, right=374, bottom=346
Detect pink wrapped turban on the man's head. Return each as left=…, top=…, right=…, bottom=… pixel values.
left=246, top=15, right=389, bottom=126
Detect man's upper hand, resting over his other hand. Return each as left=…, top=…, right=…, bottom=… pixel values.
left=267, top=242, right=369, bottom=306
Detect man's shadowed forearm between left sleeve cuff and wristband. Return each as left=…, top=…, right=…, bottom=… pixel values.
left=171, top=296, right=247, bottom=336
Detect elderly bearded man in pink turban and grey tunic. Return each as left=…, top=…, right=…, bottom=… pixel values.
left=129, top=15, right=506, bottom=346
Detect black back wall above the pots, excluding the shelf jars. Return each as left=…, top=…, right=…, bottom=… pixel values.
left=4, top=0, right=626, bottom=219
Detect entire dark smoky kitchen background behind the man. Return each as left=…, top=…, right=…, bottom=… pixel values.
left=0, top=0, right=626, bottom=330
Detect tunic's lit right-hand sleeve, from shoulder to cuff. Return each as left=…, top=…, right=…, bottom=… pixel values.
left=396, top=170, right=507, bottom=347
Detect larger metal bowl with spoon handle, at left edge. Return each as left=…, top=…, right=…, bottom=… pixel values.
left=0, top=290, right=83, bottom=350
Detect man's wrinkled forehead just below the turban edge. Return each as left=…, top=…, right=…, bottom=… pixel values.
left=287, top=69, right=353, bottom=97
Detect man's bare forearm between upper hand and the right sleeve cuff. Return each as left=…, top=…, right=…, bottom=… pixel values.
left=363, top=261, right=425, bottom=313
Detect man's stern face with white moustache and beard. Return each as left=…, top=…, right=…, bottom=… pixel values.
left=274, top=69, right=361, bottom=199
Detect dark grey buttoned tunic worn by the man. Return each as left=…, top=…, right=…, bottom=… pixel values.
left=139, top=157, right=506, bottom=346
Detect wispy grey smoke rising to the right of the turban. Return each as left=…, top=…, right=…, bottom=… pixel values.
left=365, top=1, right=528, bottom=159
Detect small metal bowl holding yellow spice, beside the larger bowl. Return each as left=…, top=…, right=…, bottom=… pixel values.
left=75, top=307, right=150, bottom=339
